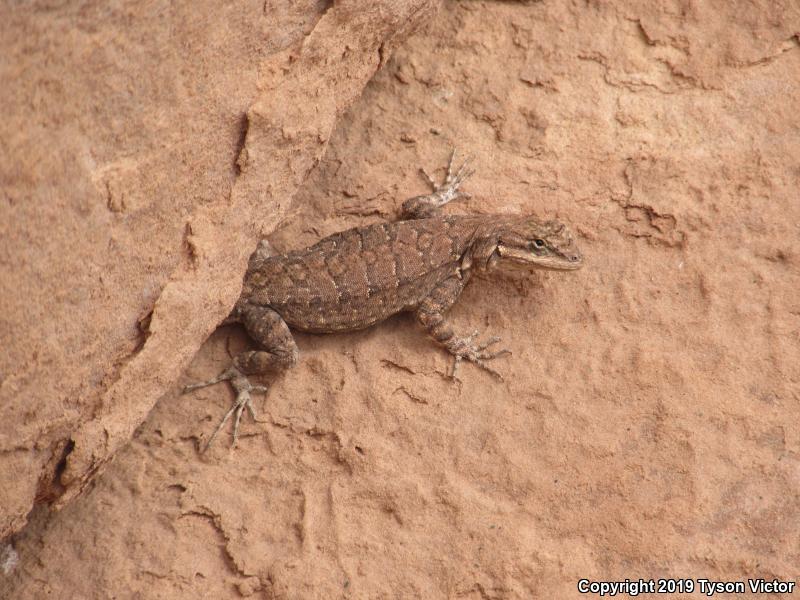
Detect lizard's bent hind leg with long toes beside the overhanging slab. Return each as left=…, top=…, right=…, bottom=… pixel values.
left=183, top=304, right=297, bottom=451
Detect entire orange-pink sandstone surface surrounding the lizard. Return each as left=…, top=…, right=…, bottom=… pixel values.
left=0, top=0, right=800, bottom=599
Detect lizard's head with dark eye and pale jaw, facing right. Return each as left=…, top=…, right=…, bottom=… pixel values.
left=497, top=217, right=583, bottom=270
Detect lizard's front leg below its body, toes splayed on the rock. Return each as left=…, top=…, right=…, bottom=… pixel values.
left=416, top=276, right=510, bottom=381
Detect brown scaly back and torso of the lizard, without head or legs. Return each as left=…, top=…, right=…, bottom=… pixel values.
left=242, top=216, right=482, bottom=333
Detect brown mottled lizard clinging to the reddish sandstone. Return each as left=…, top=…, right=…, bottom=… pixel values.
left=183, top=150, right=583, bottom=449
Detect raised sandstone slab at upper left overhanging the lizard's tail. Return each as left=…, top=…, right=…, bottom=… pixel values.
left=0, top=1, right=433, bottom=537
